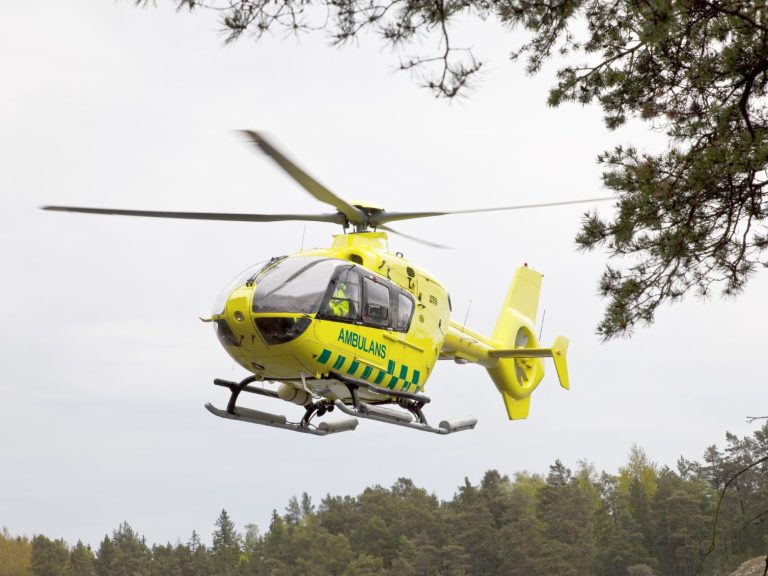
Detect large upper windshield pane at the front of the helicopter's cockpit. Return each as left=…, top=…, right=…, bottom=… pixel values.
left=253, top=256, right=345, bottom=314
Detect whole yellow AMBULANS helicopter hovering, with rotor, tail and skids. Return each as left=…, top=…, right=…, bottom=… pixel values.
left=42, top=131, right=603, bottom=436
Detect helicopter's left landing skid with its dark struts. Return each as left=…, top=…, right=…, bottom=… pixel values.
left=205, top=376, right=358, bottom=436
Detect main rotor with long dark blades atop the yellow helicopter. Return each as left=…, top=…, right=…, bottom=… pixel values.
left=41, top=130, right=614, bottom=248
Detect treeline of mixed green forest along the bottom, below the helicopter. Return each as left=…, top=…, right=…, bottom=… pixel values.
left=0, top=424, right=768, bottom=576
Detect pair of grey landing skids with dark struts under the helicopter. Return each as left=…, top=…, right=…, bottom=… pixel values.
left=205, top=374, right=477, bottom=436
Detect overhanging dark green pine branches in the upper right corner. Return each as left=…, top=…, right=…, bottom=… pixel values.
left=135, top=0, right=768, bottom=338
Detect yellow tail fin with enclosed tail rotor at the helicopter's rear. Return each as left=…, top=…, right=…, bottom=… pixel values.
left=488, top=266, right=569, bottom=420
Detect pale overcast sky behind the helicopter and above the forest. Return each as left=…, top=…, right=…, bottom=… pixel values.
left=0, top=0, right=768, bottom=545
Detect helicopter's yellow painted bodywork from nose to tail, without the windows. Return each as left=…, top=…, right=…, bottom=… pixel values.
left=212, top=232, right=568, bottom=419
